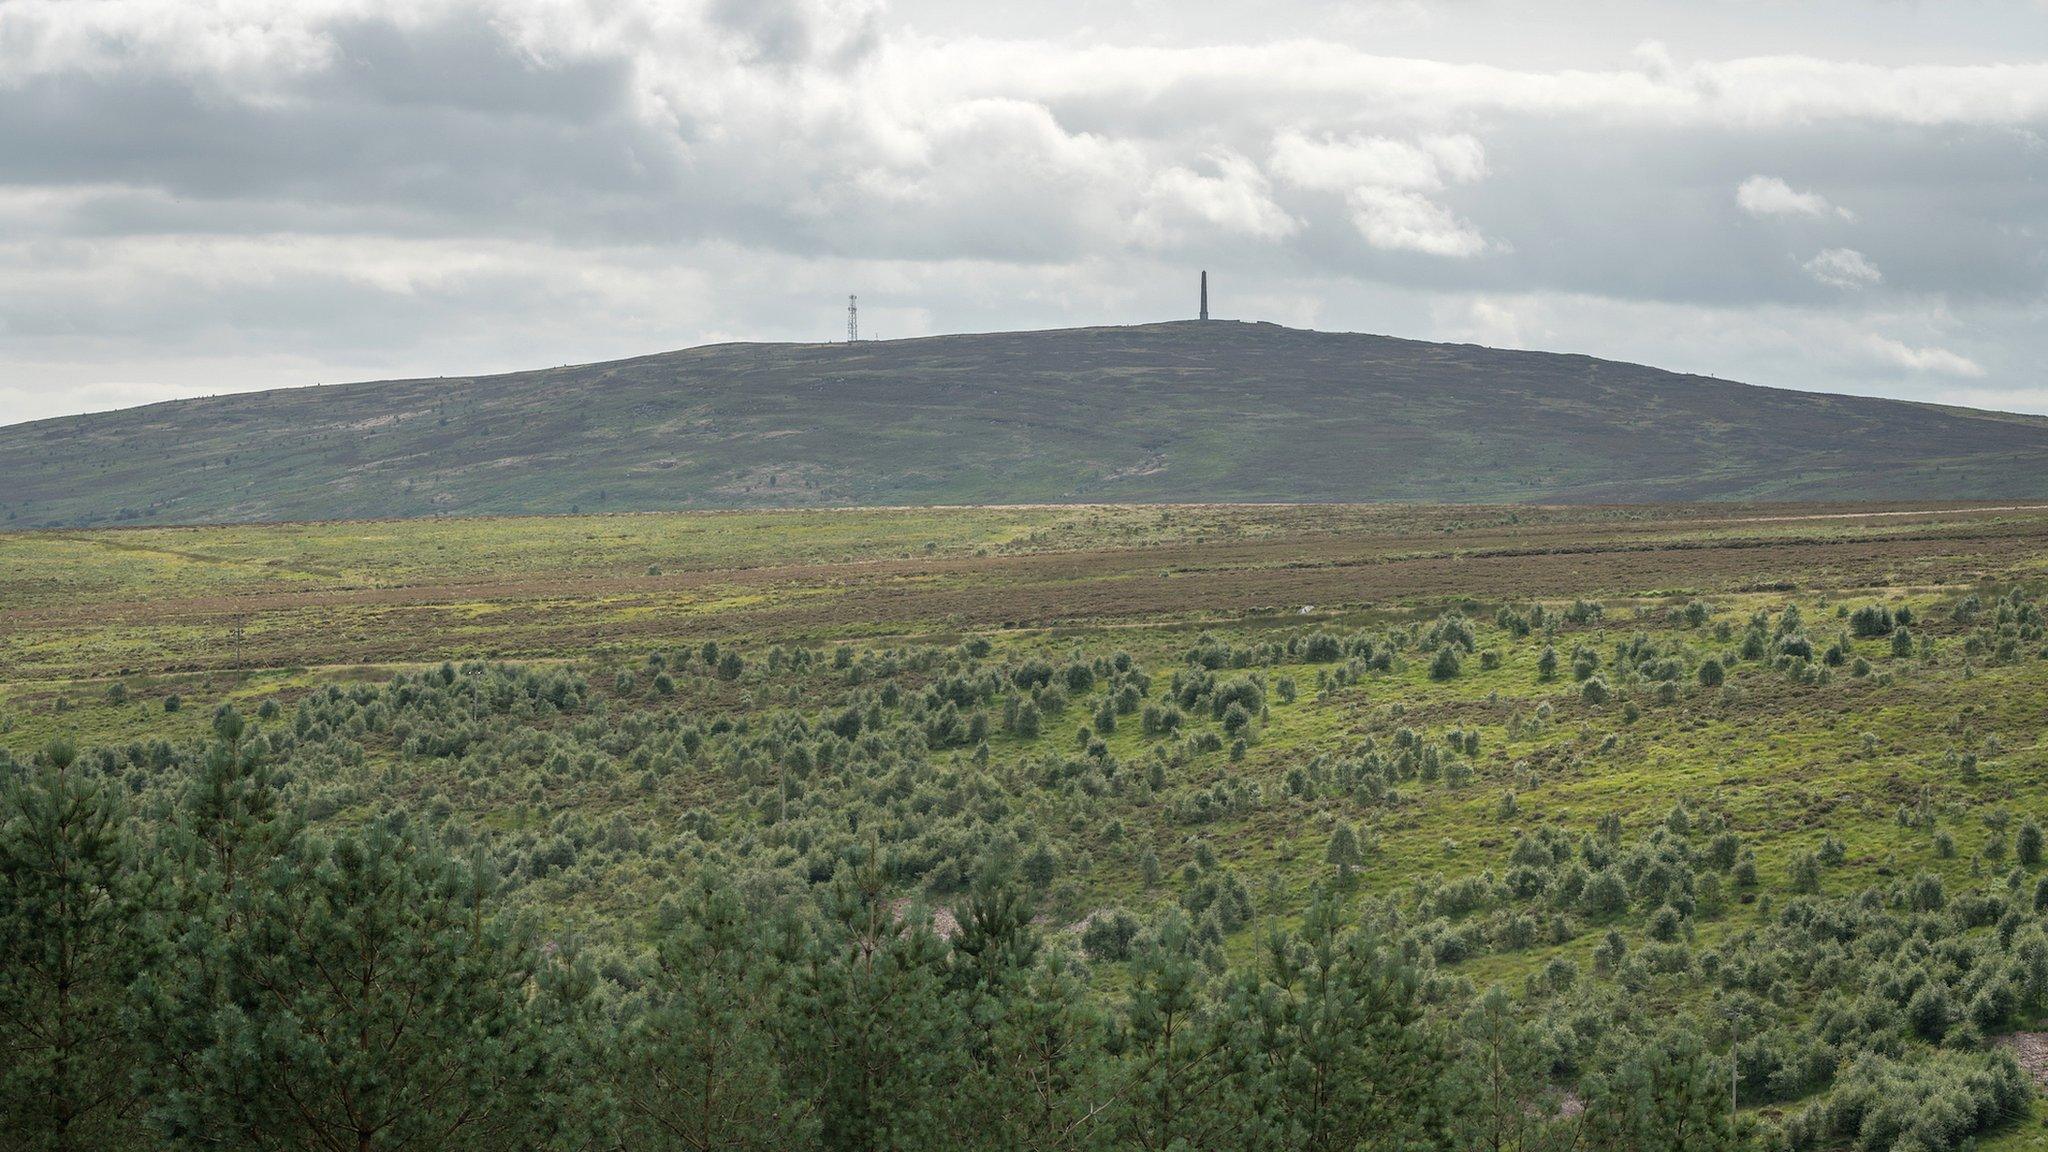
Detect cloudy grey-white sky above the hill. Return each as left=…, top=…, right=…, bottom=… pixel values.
left=0, top=0, right=2048, bottom=422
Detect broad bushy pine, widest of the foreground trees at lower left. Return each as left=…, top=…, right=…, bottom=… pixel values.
left=158, top=826, right=555, bottom=1152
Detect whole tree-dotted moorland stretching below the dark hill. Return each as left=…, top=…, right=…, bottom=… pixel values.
left=12, top=502, right=2048, bottom=1150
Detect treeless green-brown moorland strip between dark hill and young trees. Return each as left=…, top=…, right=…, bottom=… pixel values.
left=0, top=496, right=2048, bottom=681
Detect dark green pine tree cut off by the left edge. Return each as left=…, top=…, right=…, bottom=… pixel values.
left=0, top=742, right=145, bottom=1152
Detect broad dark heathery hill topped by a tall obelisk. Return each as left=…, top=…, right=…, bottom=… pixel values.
left=0, top=322, right=2048, bottom=527
